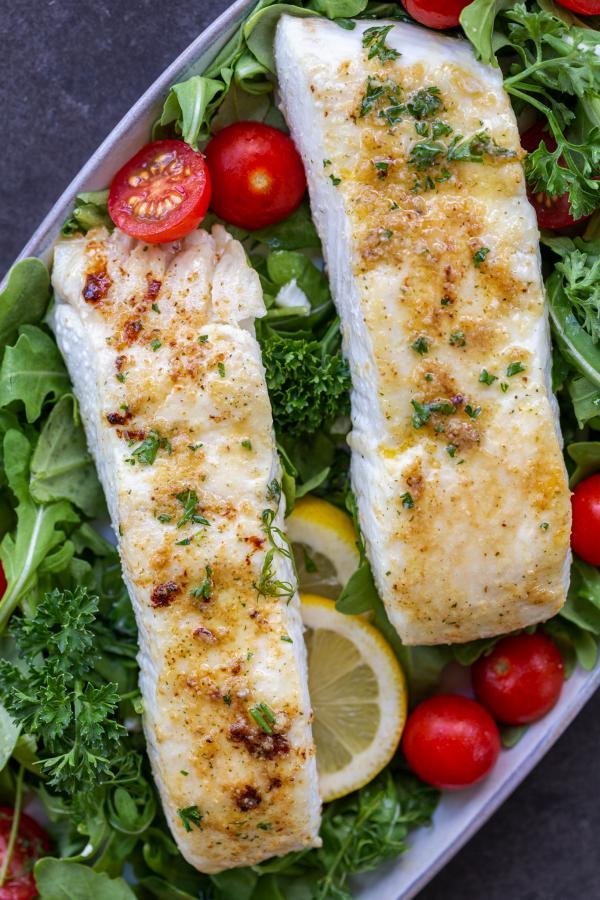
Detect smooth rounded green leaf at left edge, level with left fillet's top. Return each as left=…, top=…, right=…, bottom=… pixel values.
left=0, top=257, right=50, bottom=353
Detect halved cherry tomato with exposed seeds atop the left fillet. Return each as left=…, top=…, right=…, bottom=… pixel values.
left=108, top=141, right=211, bottom=244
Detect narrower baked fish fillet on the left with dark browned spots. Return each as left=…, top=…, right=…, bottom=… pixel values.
left=52, top=226, right=320, bottom=872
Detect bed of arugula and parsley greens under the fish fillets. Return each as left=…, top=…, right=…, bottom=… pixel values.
left=0, top=0, right=600, bottom=900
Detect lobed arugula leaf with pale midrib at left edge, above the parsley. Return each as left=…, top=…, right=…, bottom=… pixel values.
left=0, top=429, right=79, bottom=634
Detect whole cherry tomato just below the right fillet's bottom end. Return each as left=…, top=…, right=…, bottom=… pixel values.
left=471, top=632, right=565, bottom=725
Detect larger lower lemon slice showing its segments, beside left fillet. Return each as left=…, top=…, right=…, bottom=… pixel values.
left=301, top=594, right=406, bottom=802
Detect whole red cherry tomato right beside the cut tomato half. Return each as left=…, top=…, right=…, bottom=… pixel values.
left=206, top=122, right=306, bottom=229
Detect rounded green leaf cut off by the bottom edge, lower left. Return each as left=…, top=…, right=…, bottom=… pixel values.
left=34, top=857, right=135, bottom=900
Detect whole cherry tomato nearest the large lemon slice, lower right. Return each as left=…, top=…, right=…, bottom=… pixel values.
left=402, top=694, right=500, bottom=790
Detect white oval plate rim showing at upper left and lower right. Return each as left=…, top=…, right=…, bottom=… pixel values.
left=5, top=0, right=600, bottom=900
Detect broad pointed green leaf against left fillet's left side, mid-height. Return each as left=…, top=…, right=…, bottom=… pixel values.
left=30, top=394, right=104, bottom=516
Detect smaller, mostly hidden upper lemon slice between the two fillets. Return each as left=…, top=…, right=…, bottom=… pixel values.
left=286, top=497, right=359, bottom=600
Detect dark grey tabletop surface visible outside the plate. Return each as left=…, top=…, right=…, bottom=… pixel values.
left=0, top=0, right=600, bottom=900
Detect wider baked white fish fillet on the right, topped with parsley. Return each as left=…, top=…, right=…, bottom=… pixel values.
left=276, top=16, right=570, bottom=644
